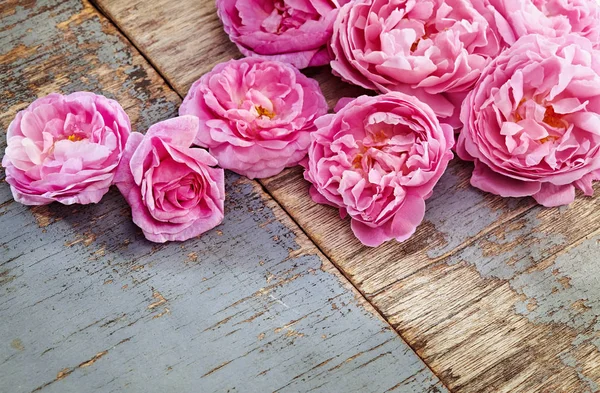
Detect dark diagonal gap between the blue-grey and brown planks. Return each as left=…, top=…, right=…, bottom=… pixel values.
left=84, top=0, right=452, bottom=392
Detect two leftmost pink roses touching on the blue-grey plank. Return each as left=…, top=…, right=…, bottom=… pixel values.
left=2, top=92, right=225, bottom=242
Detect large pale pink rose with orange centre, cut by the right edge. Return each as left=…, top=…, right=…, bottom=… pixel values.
left=457, top=35, right=600, bottom=206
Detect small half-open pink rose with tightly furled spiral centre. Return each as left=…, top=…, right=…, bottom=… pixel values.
left=115, top=116, right=225, bottom=243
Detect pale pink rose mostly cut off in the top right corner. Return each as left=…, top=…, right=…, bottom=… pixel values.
left=489, top=0, right=600, bottom=47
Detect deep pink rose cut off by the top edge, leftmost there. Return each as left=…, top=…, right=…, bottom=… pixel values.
left=217, top=0, right=349, bottom=68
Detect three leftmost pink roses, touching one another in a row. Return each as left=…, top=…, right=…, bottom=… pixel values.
left=2, top=58, right=327, bottom=242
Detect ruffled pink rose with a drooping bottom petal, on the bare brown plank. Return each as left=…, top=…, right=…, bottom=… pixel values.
left=304, top=92, right=454, bottom=246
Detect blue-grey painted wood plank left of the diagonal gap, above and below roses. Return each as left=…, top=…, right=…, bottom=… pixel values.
left=0, top=0, right=447, bottom=393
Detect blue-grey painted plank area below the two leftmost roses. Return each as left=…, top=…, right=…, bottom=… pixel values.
left=0, top=184, right=445, bottom=392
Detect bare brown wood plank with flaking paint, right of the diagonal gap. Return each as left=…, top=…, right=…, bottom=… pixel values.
left=95, top=0, right=600, bottom=393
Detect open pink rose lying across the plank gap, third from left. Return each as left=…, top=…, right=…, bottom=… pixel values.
left=179, top=58, right=327, bottom=179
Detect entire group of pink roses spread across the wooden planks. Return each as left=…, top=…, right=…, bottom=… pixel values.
left=2, top=0, right=600, bottom=246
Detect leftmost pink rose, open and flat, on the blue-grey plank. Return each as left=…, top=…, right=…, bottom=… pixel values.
left=2, top=92, right=131, bottom=205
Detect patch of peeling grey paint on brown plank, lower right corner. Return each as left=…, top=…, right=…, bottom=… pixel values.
left=436, top=196, right=600, bottom=392
